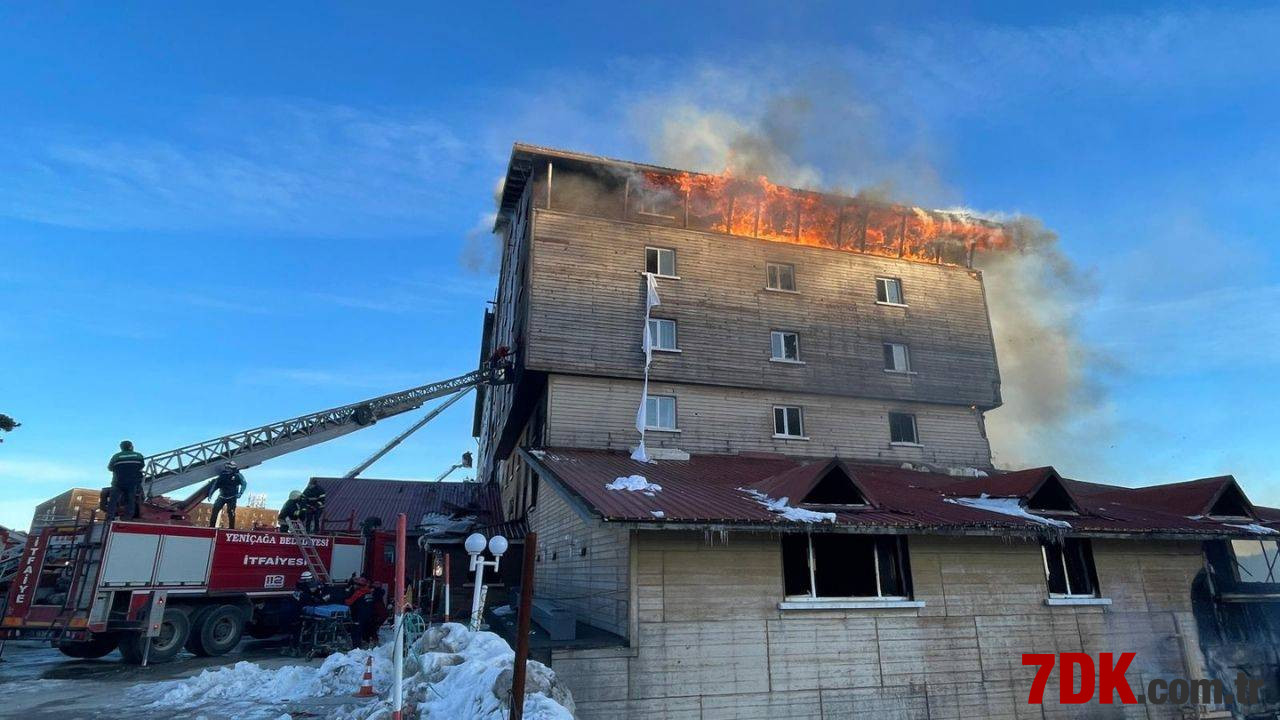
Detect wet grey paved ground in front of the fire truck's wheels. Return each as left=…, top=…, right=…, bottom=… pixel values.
left=0, top=641, right=350, bottom=720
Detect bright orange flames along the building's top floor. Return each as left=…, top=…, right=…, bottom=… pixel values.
left=640, top=170, right=1011, bottom=265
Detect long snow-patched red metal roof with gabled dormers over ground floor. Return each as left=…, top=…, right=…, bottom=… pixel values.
left=527, top=448, right=1280, bottom=536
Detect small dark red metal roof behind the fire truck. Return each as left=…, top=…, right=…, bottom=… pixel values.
left=312, top=478, right=503, bottom=529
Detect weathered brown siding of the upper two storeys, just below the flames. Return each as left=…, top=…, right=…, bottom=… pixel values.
left=526, top=210, right=998, bottom=407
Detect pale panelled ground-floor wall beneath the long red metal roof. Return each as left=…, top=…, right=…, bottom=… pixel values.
left=540, top=532, right=1202, bottom=720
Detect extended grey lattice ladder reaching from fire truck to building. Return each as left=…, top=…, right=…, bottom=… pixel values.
left=143, top=359, right=512, bottom=497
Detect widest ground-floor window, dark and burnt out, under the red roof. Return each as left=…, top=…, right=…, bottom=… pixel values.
left=782, top=534, right=911, bottom=600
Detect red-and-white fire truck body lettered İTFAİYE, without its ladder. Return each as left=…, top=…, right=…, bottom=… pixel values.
left=0, top=520, right=366, bottom=662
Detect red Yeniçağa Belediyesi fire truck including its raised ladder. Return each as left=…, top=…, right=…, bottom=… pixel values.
left=0, top=355, right=512, bottom=664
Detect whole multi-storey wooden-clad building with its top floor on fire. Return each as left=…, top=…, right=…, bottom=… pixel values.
left=475, top=145, right=1280, bottom=719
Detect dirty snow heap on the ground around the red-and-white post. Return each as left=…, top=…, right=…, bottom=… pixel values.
left=133, top=623, right=573, bottom=720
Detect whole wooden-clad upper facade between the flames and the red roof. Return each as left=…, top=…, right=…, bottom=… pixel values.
left=476, top=152, right=1001, bottom=479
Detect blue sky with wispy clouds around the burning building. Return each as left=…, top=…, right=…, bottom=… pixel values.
left=0, top=3, right=1280, bottom=527
